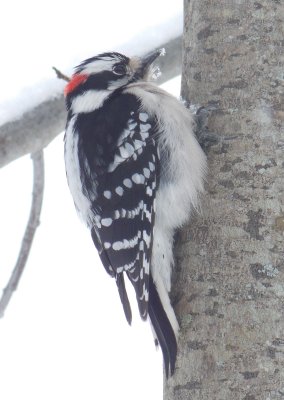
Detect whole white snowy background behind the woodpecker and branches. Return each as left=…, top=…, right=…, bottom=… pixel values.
left=0, top=0, right=182, bottom=400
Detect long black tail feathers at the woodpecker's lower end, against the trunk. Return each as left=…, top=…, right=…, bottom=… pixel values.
left=148, top=274, right=177, bottom=378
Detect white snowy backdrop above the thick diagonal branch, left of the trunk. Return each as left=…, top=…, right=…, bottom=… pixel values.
left=0, top=0, right=182, bottom=125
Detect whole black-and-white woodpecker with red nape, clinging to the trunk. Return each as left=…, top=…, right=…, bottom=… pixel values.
left=65, top=51, right=206, bottom=375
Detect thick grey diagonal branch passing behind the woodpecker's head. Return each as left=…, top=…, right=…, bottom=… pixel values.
left=0, top=36, right=181, bottom=168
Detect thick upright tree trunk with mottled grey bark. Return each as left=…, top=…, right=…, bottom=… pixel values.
left=164, top=0, right=284, bottom=400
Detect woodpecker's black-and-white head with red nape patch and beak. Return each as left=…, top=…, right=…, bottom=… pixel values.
left=64, top=50, right=163, bottom=113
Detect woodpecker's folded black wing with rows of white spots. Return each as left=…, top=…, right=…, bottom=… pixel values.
left=78, top=94, right=159, bottom=323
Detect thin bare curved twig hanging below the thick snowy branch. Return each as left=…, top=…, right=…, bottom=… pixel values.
left=0, top=150, right=44, bottom=318
